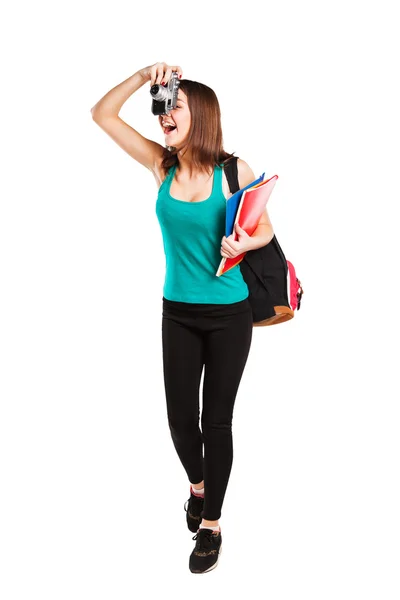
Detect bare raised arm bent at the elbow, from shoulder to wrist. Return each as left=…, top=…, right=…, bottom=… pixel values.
left=91, top=63, right=164, bottom=172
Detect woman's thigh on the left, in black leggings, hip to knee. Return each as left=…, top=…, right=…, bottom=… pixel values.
left=162, top=313, right=204, bottom=421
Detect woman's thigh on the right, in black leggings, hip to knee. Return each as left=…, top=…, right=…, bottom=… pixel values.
left=203, top=308, right=253, bottom=424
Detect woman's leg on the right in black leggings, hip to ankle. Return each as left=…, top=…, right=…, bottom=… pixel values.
left=201, top=309, right=253, bottom=524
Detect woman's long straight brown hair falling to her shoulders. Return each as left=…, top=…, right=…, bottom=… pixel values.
left=161, top=79, right=238, bottom=173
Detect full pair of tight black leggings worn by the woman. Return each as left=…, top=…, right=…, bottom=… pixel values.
left=162, top=297, right=253, bottom=521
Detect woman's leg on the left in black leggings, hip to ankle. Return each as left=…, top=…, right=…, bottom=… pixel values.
left=162, top=313, right=204, bottom=487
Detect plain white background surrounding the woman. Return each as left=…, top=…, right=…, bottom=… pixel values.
left=0, top=1, right=400, bottom=600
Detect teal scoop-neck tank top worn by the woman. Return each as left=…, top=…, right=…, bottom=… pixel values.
left=156, top=165, right=249, bottom=304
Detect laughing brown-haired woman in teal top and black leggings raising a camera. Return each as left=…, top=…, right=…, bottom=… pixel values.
left=92, top=63, right=273, bottom=573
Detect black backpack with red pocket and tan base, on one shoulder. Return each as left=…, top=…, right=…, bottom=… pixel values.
left=221, top=156, right=303, bottom=327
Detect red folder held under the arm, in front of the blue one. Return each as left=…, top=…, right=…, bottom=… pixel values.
left=216, top=175, right=278, bottom=277
